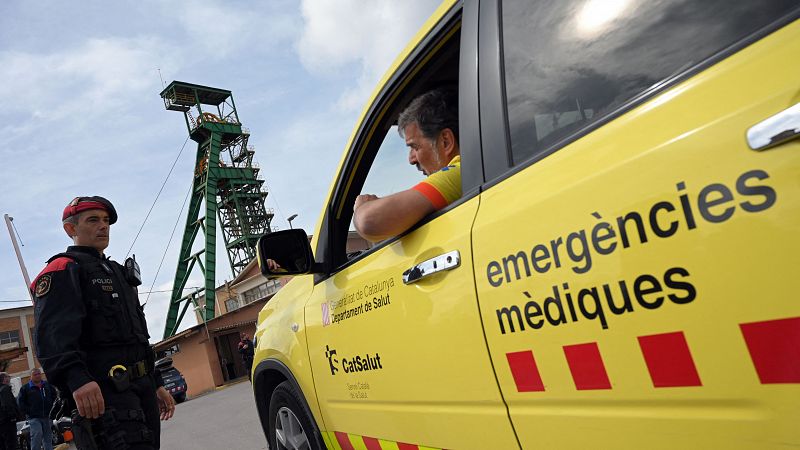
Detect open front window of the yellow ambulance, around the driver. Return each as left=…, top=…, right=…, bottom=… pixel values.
left=322, top=16, right=461, bottom=270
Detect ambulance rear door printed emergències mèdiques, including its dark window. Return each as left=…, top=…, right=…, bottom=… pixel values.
left=473, top=0, right=800, bottom=449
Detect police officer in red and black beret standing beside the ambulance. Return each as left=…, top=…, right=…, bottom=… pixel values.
left=31, top=196, right=175, bottom=450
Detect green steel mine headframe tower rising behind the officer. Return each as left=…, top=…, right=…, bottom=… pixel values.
left=161, top=81, right=273, bottom=339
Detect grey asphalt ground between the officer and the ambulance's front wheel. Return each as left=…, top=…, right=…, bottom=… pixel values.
left=161, top=381, right=267, bottom=450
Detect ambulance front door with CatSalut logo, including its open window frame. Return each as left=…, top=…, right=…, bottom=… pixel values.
left=305, top=5, right=518, bottom=449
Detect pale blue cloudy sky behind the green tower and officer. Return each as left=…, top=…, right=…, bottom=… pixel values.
left=0, top=0, right=438, bottom=341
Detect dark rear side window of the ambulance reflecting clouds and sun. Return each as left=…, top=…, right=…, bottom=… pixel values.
left=502, top=0, right=797, bottom=165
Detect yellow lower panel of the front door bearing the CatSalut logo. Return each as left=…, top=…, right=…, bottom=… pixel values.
left=306, top=197, right=517, bottom=449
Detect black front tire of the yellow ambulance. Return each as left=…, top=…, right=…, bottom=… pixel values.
left=267, top=381, right=325, bottom=450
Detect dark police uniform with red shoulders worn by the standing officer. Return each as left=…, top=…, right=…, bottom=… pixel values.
left=31, top=199, right=163, bottom=450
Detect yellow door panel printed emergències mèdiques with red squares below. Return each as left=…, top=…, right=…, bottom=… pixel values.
left=473, top=16, right=800, bottom=449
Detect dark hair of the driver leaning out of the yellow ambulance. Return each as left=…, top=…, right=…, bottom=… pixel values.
left=397, top=88, right=458, bottom=142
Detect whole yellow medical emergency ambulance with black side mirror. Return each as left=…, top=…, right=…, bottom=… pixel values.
left=253, top=0, right=800, bottom=450
